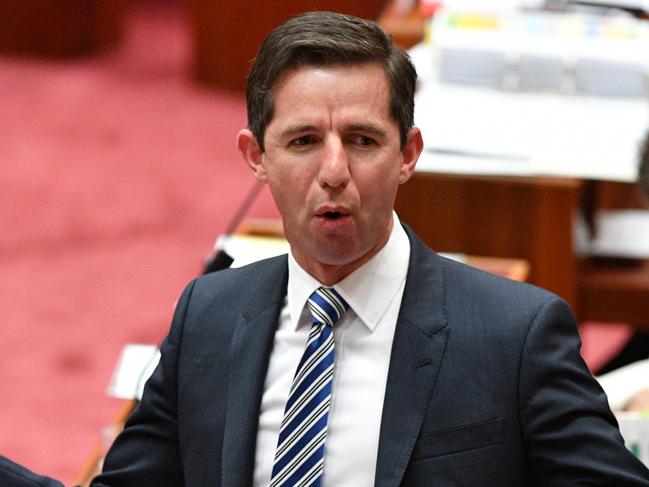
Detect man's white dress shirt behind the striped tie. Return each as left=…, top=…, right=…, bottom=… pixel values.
left=254, top=214, right=410, bottom=487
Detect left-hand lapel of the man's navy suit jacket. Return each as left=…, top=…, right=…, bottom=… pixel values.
left=221, top=258, right=288, bottom=487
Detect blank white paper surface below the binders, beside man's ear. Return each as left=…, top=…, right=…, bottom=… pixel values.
left=415, top=77, right=649, bottom=182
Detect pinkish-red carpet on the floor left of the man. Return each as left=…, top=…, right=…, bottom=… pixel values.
left=0, top=2, right=275, bottom=483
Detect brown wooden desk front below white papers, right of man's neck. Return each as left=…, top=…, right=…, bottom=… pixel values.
left=396, top=173, right=649, bottom=328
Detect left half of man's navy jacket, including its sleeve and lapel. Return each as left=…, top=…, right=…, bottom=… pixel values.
left=92, top=256, right=288, bottom=487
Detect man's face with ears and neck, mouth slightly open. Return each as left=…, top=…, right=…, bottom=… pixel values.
left=238, top=64, right=422, bottom=285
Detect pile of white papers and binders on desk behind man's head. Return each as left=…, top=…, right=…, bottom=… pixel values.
left=410, top=10, right=649, bottom=182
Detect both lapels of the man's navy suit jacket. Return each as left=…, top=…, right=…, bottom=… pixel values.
left=221, top=225, right=447, bottom=487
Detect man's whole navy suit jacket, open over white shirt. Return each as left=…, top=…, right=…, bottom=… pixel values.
left=93, top=230, right=649, bottom=487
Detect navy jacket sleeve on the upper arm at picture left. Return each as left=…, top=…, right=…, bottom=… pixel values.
left=91, top=282, right=194, bottom=487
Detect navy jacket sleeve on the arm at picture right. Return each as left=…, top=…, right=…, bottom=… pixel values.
left=519, top=297, right=649, bottom=487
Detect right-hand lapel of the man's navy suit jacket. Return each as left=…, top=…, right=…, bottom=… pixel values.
left=375, top=227, right=448, bottom=487
